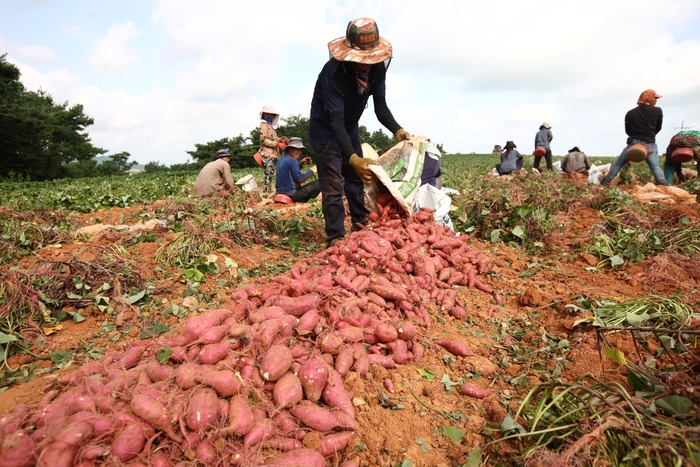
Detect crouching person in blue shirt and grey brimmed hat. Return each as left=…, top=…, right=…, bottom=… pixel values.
left=275, top=137, right=321, bottom=203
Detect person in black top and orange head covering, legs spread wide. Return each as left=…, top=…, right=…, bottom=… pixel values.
left=600, top=89, right=668, bottom=185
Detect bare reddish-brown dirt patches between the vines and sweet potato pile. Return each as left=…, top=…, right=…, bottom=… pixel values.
left=0, top=187, right=700, bottom=467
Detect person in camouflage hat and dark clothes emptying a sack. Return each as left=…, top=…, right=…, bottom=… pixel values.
left=309, top=18, right=411, bottom=246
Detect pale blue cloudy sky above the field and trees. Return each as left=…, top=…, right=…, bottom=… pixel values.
left=0, top=0, right=700, bottom=165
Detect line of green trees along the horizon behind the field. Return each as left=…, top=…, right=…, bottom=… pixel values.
left=0, top=54, right=438, bottom=181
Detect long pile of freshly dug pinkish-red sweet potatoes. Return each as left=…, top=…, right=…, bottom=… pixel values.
left=0, top=211, right=492, bottom=467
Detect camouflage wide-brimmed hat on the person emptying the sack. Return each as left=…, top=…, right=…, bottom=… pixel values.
left=328, top=18, right=392, bottom=65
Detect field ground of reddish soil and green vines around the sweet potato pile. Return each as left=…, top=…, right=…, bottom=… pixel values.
left=0, top=155, right=700, bottom=467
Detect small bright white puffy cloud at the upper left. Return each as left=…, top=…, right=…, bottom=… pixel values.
left=88, top=21, right=141, bottom=74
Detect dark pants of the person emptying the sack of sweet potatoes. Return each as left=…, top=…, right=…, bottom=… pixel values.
left=311, top=137, right=369, bottom=242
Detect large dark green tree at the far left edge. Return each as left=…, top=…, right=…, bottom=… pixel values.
left=0, top=54, right=107, bottom=180
